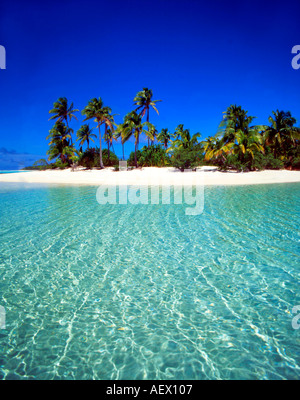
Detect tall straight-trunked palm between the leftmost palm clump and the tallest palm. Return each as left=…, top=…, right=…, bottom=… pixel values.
left=82, top=97, right=113, bottom=168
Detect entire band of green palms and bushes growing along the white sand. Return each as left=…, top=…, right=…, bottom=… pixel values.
left=28, top=88, right=300, bottom=171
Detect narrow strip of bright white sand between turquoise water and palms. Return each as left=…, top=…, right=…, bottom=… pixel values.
left=0, top=167, right=300, bottom=186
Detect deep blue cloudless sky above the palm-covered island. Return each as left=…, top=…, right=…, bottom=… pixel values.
left=0, top=0, right=300, bottom=169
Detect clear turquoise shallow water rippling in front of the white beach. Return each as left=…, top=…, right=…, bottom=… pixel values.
left=0, top=184, right=300, bottom=379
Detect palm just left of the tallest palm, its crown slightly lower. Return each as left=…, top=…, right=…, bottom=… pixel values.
left=118, top=111, right=154, bottom=167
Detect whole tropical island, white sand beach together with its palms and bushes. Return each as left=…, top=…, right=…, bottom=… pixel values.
left=0, top=88, right=300, bottom=185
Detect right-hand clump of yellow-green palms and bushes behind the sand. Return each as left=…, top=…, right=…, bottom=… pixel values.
left=204, top=105, right=300, bottom=171
